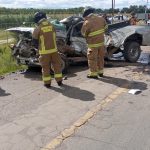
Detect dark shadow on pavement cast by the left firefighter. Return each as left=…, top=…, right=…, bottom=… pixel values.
left=51, top=85, right=95, bottom=101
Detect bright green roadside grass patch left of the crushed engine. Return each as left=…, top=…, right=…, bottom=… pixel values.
left=0, top=44, right=26, bottom=75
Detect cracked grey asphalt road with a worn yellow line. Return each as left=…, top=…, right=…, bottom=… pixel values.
left=0, top=47, right=150, bottom=150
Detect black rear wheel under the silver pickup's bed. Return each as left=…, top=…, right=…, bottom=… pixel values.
left=123, top=41, right=141, bottom=63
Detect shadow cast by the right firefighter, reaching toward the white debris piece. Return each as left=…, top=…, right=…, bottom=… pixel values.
left=99, top=76, right=147, bottom=90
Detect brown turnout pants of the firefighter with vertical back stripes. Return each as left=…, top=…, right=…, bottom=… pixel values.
left=39, top=52, right=62, bottom=84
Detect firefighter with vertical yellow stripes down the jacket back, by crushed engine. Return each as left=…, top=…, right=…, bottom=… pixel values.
left=32, top=12, right=62, bottom=88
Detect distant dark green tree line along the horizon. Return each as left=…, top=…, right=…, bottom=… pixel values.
left=0, top=5, right=150, bottom=15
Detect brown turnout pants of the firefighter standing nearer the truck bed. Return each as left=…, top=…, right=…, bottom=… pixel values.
left=87, top=46, right=105, bottom=76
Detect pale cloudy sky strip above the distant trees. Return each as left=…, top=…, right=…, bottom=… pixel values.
left=0, top=0, right=150, bottom=9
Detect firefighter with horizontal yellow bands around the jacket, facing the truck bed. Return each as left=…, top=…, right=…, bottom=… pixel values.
left=81, top=8, right=107, bottom=78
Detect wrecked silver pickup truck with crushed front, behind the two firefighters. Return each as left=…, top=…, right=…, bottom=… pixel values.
left=7, top=16, right=150, bottom=70
